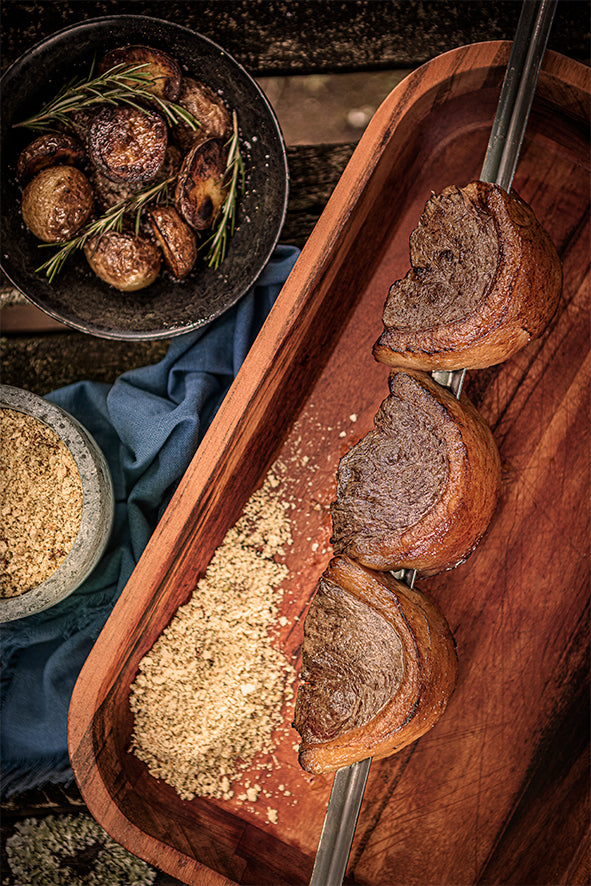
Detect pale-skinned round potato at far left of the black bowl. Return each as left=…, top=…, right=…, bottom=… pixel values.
left=21, top=166, right=94, bottom=243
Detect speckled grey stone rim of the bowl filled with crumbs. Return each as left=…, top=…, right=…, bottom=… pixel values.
left=0, top=384, right=115, bottom=623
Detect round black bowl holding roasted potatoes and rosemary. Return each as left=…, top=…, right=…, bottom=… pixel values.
left=0, top=15, right=289, bottom=340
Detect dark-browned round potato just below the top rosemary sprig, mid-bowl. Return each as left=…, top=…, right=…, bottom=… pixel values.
left=88, top=106, right=168, bottom=183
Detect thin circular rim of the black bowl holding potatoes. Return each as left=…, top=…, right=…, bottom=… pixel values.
left=0, top=13, right=290, bottom=341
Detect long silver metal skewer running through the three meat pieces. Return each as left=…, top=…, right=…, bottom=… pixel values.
left=310, top=0, right=558, bottom=886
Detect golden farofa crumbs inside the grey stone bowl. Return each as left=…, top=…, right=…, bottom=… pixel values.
left=0, top=407, right=82, bottom=598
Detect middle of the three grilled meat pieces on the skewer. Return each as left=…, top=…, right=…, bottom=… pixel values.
left=331, top=370, right=500, bottom=575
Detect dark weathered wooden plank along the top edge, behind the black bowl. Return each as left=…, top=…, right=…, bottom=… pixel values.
left=2, top=0, right=589, bottom=75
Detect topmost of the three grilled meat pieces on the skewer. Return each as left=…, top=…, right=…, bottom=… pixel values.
left=374, top=181, right=562, bottom=370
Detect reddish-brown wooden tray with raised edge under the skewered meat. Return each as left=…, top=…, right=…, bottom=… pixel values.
left=69, top=42, right=590, bottom=886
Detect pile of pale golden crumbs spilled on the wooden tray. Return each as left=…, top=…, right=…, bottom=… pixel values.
left=130, top=470, right=296, bottom=800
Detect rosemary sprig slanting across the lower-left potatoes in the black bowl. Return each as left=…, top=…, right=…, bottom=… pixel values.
left=36, top=176, right=176, bottom=283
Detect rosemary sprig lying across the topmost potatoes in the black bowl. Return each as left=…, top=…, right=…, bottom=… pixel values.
left=14, top=62, right=201, bottom=131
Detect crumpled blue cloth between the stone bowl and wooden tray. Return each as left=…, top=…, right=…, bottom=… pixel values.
left=0, top=246, right=298, bottom=796
